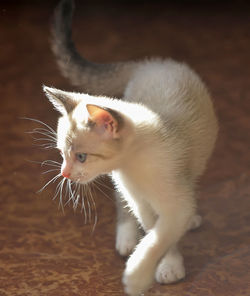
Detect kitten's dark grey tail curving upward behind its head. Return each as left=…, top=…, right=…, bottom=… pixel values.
left=52, top=0, right=137, bottom=97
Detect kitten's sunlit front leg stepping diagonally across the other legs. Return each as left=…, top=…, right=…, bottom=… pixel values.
left=123, top=188, right=194, bottom=296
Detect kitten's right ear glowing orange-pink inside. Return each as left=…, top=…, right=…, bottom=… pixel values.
left=86, top=104, right=123, bottom=139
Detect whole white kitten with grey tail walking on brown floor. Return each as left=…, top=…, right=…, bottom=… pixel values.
left=44, top=0, right=218, bottom=296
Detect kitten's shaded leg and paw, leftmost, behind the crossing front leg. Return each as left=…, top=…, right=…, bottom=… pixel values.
left=116, top=194, right=140, bottom=256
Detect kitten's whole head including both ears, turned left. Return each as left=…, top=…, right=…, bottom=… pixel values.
left=43, top=86, right=131, bottom=183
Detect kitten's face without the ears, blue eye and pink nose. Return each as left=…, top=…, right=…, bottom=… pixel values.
left=57, top=111, right=123, bottom=183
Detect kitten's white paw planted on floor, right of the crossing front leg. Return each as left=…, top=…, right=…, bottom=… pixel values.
left=155, top=254, right=185, bottom=284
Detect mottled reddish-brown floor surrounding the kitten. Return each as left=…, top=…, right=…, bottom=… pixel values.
left=0, top=1, right=250, bottom=296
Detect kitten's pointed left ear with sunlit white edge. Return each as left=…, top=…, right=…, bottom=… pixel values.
left=43, top=85, right=78, bottom=115
